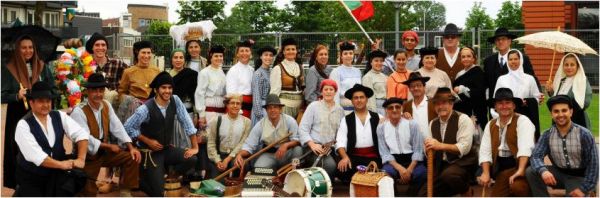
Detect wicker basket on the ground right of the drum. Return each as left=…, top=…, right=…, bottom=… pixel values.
left=351, top=161, right=387, bottom=197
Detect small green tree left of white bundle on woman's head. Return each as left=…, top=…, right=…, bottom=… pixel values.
left=143, top=20, right=173, bottom=56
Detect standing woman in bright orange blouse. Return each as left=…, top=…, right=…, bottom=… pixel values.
left=386, top=49, right=420, bottom=100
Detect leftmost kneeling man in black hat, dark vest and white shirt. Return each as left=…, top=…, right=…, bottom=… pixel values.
left=14, top=82, right=89, bottom=197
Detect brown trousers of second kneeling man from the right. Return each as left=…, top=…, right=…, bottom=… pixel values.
left=492, top=167, right=531, bottom=197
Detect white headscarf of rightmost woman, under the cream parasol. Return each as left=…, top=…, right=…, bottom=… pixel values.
left=552, top=53, right=587, bottom=107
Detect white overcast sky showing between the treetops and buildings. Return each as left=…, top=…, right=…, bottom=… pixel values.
left=78, top=0, right=505, bottom=27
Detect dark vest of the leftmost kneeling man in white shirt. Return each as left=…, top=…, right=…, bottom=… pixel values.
left=17, top=111, right=65, bottom=176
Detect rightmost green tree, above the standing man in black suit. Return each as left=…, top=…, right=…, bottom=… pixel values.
left=495, top=1, right=524, bottom=30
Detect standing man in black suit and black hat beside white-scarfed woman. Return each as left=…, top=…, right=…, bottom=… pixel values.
left=480, top=27, right=541, bottom=98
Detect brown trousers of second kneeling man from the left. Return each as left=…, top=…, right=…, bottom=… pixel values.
left=79, top=151, right=140, bottom=197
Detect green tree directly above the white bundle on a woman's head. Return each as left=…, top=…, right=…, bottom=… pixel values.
left=175, top=0, right=225, bottom=24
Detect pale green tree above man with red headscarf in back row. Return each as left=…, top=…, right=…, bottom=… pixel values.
left=412, top=1, right=446, bottom=30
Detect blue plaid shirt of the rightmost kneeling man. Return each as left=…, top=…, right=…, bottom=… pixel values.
left=530, top=123, right=598, bottom=192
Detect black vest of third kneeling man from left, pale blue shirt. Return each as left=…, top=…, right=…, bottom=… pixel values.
left=140, top=97, right=177, bottom=148
